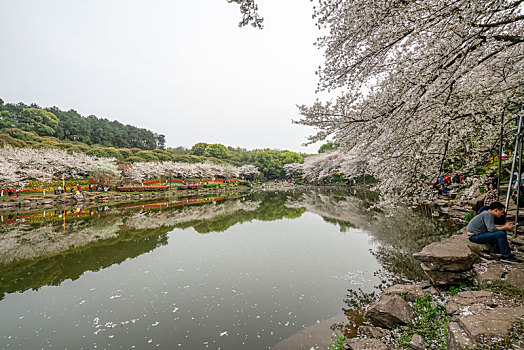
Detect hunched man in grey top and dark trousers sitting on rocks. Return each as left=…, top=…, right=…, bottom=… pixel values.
left=467, top=202, right=523, bottom=263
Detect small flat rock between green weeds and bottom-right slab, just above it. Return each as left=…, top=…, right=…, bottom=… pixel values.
left=446, top=290, right=495, bottom=315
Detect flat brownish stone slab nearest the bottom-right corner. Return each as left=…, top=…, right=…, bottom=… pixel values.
left=457, top=306, right=524, bottom=343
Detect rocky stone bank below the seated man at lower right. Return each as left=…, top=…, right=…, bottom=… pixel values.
left=338, top=198, right=524, bottom=349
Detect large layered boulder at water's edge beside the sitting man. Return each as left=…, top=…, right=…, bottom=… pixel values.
left=413, top=234, right=481, bottom=285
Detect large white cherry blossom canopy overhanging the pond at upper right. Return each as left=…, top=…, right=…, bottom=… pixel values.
left=298, top=0, right=524, bottom=200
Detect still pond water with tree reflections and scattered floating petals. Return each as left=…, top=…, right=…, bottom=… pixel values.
left=0, top=191, right=449, bottom=349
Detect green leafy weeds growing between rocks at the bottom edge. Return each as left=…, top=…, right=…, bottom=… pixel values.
left=394, top=296, right=451, bottom=349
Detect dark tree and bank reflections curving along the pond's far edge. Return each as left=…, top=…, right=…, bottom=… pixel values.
left=0, top=191, right=450, bottom=322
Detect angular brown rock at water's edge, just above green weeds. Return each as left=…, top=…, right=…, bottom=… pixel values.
left=365, top=295, right=416, bottom=328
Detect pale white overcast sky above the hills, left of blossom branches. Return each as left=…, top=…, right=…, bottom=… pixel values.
left=0, top=0, right=322, bottom=153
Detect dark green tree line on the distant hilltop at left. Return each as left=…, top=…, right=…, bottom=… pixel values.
left=0, top=99, right=166, bottom=150
